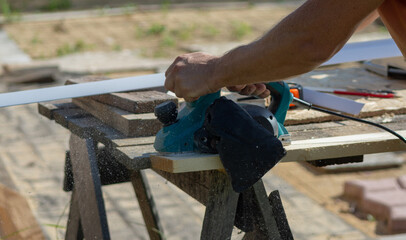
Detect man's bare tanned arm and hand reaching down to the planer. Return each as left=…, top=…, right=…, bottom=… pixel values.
left=165, top=0, right=383, bottom=100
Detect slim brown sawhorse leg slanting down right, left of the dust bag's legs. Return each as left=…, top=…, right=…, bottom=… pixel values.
left=131, top=171, right=164, bottom=240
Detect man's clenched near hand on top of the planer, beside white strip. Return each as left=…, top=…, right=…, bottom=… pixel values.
left=165, top=53, right=222, bottom=101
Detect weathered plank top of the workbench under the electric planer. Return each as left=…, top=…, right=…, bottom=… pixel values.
left=39, top=64, right=406, bottom=171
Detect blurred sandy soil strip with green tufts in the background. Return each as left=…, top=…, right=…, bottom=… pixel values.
left=4, top=4, right=382, bottom=59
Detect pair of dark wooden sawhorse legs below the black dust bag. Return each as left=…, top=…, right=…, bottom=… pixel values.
left=201, top=173, right=293, bottom=240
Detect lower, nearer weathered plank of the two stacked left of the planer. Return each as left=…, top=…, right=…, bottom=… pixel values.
left=73, top=98, right=162, bottom=137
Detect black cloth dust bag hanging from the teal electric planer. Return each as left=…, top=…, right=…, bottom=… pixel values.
left=203, top=97, right=286, bottom=193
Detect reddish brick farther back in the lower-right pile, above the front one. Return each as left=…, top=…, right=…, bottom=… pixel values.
left=343, top=178, right=400, bottom=203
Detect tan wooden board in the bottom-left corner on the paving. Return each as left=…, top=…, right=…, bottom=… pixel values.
left=0, top=184, right=45, bottom=240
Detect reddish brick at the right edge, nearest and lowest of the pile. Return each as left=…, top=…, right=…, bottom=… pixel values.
left=359, top=189, right=406, bottom=220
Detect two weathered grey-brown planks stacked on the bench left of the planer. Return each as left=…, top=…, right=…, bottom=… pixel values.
left=67, top=77, right=178, bottom=137
